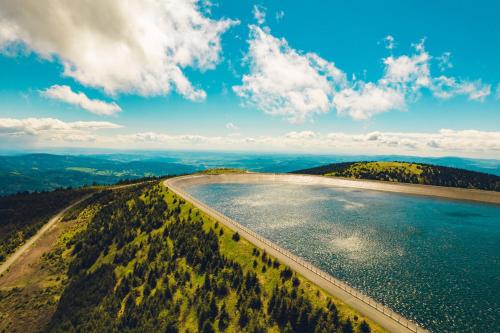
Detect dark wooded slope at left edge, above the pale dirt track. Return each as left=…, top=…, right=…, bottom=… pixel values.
left=0, top=189, right=90, bottom=262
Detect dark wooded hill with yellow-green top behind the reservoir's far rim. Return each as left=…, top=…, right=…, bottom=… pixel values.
left=293, top=161, right=500, bottom=191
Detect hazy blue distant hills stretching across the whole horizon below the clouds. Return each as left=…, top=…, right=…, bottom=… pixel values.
left=0, top=151, right=500, bottom=195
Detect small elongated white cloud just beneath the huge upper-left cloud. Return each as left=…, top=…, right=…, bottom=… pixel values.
left=41, top=85, right=122, bottom=116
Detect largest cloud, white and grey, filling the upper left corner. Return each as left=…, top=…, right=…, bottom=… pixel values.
left=0, top=0, right=237, bottom=100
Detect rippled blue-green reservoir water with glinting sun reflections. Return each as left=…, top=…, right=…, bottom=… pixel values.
left=187, top=184, right=500, bottom=332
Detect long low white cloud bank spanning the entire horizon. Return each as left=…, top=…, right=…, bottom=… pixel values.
left=0, top=118, right=500, bottom=158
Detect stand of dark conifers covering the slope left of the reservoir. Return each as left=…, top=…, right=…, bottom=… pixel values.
left=46, top=184, right=370, bottom=332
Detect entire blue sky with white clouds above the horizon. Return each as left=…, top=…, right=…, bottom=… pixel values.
left=0, top=0, right=500, bottom=159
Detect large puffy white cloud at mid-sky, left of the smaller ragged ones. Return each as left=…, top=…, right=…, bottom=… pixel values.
left=233, top=26, right=345, bottom=122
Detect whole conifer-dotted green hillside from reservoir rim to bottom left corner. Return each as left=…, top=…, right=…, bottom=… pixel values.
left=0, top=183, right=383, bottom=332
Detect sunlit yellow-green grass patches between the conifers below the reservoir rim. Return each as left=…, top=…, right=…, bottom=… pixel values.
left=33, top=185, right=383, bottom=332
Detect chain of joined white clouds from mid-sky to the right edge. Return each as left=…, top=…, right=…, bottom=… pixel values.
left=233, top=30, right=491, bottom=123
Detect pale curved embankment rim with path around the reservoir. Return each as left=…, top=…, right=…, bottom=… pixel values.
left=164, top=173, right=492, bottom=332
